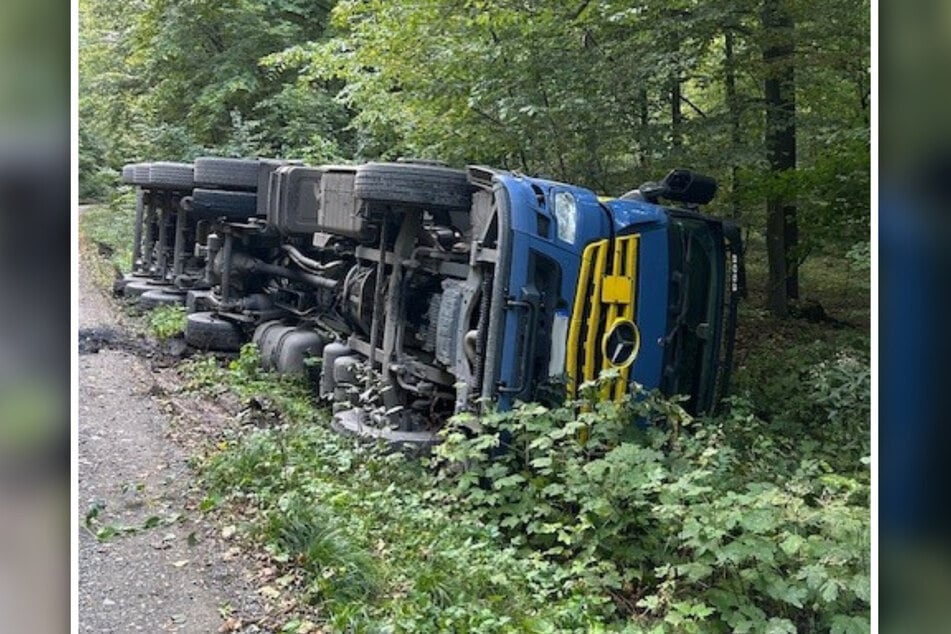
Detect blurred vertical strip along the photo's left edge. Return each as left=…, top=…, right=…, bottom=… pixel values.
left=0, top=0, right=73, bottom=632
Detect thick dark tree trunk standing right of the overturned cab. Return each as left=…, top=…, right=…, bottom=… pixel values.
left=763, top=0, right=799, bottom=317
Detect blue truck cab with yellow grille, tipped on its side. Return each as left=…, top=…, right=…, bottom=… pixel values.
left=470, top=168, right=742, bottom=413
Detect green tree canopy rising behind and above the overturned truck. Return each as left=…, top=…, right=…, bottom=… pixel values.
left=79, top=0, right=870, bottom=308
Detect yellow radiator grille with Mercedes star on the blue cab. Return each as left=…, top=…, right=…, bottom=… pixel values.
left=565, top=235, right=638, bottom=399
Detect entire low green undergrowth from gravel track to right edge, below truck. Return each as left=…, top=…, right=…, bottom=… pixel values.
left=185, top=346, right=870, bottom=632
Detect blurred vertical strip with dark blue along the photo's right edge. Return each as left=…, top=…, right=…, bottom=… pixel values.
left=878, top=0, right=951, bottom=632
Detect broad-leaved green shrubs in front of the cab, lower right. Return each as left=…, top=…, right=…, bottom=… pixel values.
left=431, top=378, right=870, bottom=632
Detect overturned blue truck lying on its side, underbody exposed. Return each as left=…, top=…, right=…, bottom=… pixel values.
left=119, top=162, right=743, bottom=444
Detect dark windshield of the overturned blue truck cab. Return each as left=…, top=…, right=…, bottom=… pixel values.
left=662, top=212, right=725, bottom=414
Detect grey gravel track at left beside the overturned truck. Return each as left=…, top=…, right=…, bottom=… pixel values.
left=78, top=233, right=260, bottom=632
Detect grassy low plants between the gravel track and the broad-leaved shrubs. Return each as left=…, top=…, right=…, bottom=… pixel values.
left=197, top=354, right=610, bottom=632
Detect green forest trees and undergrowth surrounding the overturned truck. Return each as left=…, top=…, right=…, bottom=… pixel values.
left=79, top=0, right=871, bottom=632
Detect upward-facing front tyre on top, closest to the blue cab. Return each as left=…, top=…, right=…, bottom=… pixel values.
left=353, top=163, right=472, bottom=210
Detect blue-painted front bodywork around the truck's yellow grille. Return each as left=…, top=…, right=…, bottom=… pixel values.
left=495, top=174, right=669, bottom=409
